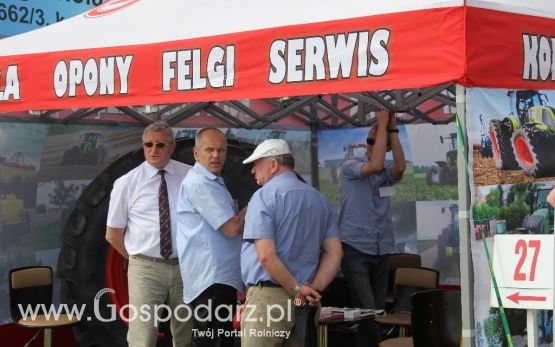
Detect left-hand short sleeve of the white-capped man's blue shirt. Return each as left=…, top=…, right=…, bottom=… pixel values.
left=243, top=191, right=275, bottom=240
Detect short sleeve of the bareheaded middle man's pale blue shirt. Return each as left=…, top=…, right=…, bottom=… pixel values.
left=187, top=182, right=235, bottom=230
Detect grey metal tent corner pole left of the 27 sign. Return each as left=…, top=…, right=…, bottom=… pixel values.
left=456, top=84, right=475, bottom=347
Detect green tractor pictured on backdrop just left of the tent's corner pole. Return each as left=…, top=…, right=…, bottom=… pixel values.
left=426, top=133, right=458, bottom=186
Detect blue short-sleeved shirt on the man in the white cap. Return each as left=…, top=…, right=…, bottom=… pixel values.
left=241, top=172, right=338, bottom=284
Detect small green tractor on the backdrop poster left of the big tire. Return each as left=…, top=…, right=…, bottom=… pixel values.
left=62, top=132, right=107, bottom=165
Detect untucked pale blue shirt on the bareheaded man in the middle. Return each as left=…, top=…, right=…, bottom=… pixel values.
left=177, top=163, right=244, bottom=304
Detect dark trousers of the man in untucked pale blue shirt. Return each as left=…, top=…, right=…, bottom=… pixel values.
left=191, top=283, right=237, bottom=347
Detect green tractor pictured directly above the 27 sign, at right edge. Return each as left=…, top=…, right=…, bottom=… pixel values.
left=515, top=184, right=553, bottom=234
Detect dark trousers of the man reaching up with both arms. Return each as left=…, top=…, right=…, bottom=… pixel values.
left=341, top=243, right=389, bottom=347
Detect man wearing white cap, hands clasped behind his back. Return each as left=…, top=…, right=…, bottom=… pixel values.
left=241, top=139, right=343, bottom=347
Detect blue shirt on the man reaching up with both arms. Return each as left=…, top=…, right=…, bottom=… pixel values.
left=339, top=157, right=398, bottom=255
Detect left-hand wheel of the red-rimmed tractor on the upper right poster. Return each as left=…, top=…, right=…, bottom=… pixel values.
left=489, top=118, right=519, bottom=170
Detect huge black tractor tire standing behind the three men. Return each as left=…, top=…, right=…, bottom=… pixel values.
left=58, top=139, right=258, bottom=347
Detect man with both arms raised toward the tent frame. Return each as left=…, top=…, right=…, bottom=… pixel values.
left=339, top=110, right=406, bottom=309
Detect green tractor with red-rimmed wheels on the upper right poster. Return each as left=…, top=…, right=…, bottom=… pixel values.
left=489, top=90, right=555, bottom=177
